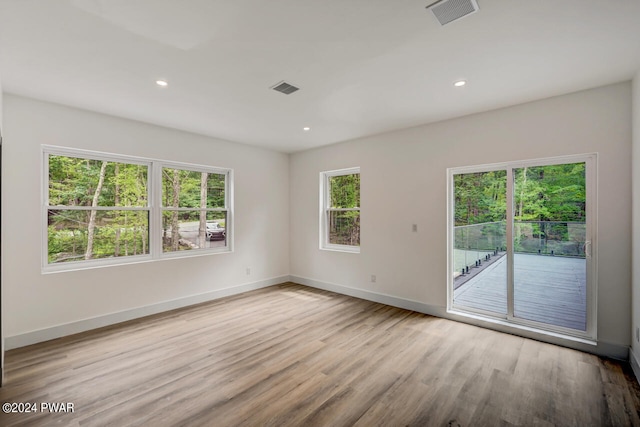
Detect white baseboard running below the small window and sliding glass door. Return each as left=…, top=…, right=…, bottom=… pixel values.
left=290, top=275, right=630, bottom=361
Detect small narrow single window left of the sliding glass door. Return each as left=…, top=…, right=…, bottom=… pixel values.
left=320, top=168, right=360, bottom=252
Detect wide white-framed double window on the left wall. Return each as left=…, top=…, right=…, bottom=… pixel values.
left=43, top=146, right=231, bottom=271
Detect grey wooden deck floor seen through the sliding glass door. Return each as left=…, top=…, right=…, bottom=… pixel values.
left=454, top=254, right=587, bottom=331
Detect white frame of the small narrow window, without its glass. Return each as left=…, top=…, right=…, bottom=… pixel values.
left=319, top=166, right=362, bottom=253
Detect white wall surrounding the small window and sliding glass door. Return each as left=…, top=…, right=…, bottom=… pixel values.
left=290, top=82, right=631, bottom=357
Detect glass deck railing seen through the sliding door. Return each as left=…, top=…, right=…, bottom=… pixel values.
left=453, top=221, right=586, bottom=277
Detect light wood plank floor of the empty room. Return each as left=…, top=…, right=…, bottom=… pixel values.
left=0, top=283, right=640, bottom=427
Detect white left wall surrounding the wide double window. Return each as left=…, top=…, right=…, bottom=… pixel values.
left=2, top=94, right=289, bottom=348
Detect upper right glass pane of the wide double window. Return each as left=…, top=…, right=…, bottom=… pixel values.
left=162, top=168, right=226, bottom=208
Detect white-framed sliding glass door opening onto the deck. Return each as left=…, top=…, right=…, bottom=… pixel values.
left=448, top=154, right=596, bottom=338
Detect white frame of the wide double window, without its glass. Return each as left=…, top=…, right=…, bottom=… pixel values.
left=40, top=145, right=234, bottom=274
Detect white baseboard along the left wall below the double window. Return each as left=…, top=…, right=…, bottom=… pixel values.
left=5, top=276, right=290, bottom=350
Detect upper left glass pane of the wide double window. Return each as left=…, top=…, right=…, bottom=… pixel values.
left=48, top=155, right=148, bottom=207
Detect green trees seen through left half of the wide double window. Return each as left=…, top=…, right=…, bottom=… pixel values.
left=48, top=155, right=149, bottom=263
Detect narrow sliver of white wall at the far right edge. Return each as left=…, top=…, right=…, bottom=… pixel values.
left=630, top=71, right=640, bottom=378
